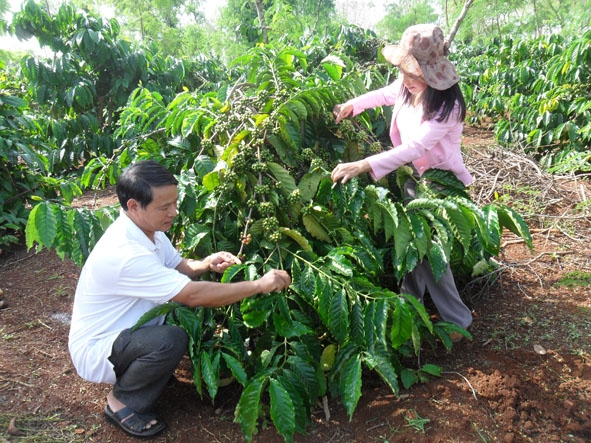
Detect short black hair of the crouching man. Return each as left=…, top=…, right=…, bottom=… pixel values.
left=117, top=160, right=179, bottom=211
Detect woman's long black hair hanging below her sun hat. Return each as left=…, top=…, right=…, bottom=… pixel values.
left=402, top=83, right=466, bottom=122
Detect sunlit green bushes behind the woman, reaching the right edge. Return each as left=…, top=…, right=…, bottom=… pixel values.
left=454, top=31, right=591, bottom=171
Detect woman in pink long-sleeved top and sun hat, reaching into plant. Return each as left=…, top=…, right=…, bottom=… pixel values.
left=331, top=24, right=472, bottom=341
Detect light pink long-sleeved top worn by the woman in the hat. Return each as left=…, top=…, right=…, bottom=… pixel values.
left=347, top=79, right=472, bottom=186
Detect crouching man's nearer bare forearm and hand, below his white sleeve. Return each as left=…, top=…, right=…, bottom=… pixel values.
left=172, top=265, right=291, bottom=308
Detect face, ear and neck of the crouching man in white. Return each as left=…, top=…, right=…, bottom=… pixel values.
left=127, top=185, right=178, bottom=239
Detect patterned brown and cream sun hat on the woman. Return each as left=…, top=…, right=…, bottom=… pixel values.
left=382, top=24, right=459, bottom=91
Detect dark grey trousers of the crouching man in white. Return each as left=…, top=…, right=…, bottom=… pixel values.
left=109, top=325, right=189, bottom=413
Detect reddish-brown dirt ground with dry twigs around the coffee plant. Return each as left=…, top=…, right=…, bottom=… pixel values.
left=0, top=131, right=591, bottom=443
